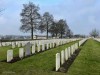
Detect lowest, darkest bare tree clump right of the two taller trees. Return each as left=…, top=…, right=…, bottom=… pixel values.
left=49, top=19, right=71, bottom=38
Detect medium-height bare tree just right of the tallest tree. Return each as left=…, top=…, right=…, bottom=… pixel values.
left=39, top=12, right=53, bottom=39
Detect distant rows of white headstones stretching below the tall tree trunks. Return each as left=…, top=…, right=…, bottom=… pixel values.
left=0, top=38, right=79, bottom=48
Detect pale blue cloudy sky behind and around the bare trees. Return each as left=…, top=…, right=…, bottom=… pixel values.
left=0, top=0, right=100, bottom=35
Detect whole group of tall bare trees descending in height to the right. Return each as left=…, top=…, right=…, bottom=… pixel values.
left=20, top=2, right=73, bottom=39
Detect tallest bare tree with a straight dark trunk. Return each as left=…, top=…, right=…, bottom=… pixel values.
left=20, top=2, right=40, bottom=39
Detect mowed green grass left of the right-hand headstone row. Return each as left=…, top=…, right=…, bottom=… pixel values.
left=0, top=41, right=78, bottom=75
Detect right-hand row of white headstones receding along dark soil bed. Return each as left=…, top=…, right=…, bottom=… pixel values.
left=56, top=39, right=86, bottom=71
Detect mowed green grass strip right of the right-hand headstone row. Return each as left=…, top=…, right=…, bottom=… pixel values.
left=67, top=39, right=100, bottom=75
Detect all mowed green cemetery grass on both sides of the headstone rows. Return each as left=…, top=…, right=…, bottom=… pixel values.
left=0, top=39, right=100, bottom=75
